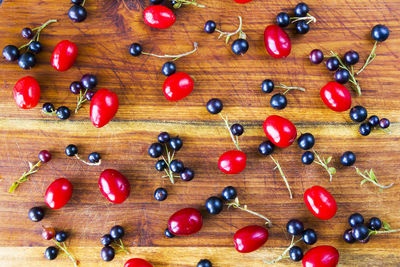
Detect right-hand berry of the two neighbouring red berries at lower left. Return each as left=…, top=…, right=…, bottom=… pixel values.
left=99, top=169, right=131, bottom=204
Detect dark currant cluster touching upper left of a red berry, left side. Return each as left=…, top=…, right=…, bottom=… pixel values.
left=69, top=73, right=97, bottom=113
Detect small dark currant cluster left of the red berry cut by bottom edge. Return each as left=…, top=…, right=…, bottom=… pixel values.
left=100, top=225, right=129, bottom=261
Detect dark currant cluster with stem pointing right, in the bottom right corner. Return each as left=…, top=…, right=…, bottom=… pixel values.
left=343, top=213, right=400, bottom=244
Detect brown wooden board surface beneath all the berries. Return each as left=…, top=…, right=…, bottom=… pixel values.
left=0, top=0, right=400, bottom=267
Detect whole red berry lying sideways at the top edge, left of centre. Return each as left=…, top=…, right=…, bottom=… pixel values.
left=143, top=5, right=176, bottom=29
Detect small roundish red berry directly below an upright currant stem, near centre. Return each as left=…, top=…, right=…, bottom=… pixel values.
left=218, top=150, right=247, bottom=174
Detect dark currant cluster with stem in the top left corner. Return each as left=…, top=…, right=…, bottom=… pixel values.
left=3, top=19, right=57, bottom=70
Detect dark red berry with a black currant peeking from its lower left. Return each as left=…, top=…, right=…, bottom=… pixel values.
left=168, top=208, right=203, bottom=236
